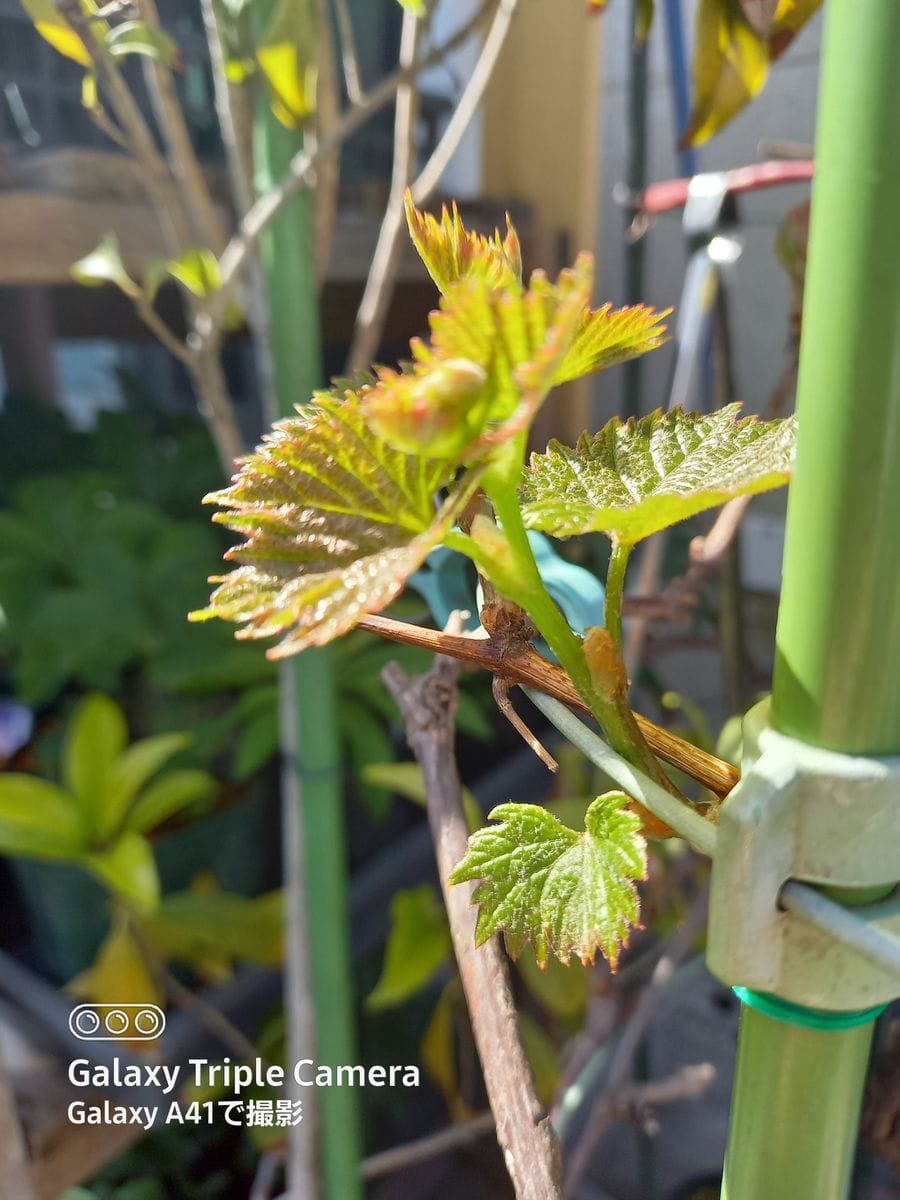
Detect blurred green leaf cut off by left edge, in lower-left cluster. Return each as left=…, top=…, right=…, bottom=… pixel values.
left=0, top=774, right=86, bottom=858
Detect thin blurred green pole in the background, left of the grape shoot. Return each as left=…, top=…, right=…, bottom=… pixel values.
left=253, top=0, right=362, bottom=1200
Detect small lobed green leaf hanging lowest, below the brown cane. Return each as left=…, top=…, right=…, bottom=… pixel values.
left=450, top=792, right=647, bottom=970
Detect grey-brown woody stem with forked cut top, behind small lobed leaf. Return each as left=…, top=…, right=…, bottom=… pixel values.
left=383, top=658, right=563, bottom=1200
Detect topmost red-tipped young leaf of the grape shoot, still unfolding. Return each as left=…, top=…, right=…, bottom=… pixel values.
left=406, top=191, right=522, bottom=292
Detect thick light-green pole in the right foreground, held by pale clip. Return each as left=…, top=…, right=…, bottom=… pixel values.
left=722, top=0, right=900, bottom=1200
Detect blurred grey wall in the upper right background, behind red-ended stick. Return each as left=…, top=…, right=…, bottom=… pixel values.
left=595, top=0, right=822, bottom=422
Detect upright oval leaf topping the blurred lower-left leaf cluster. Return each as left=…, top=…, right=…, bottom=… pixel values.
left=62, top=692, right=128, bottom=833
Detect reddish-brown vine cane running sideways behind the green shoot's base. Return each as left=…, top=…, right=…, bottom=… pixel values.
left=360, top=617, right=740, bottom=797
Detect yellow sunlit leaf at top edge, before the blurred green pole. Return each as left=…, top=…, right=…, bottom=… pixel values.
left=257, top=0, right=318, bottom=130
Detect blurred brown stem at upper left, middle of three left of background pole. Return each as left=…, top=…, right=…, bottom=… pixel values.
left=137, top=0, right=227, bottom=254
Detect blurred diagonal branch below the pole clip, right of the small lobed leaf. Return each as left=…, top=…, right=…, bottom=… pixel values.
left=565, top=887, right=709, bottom=1195
